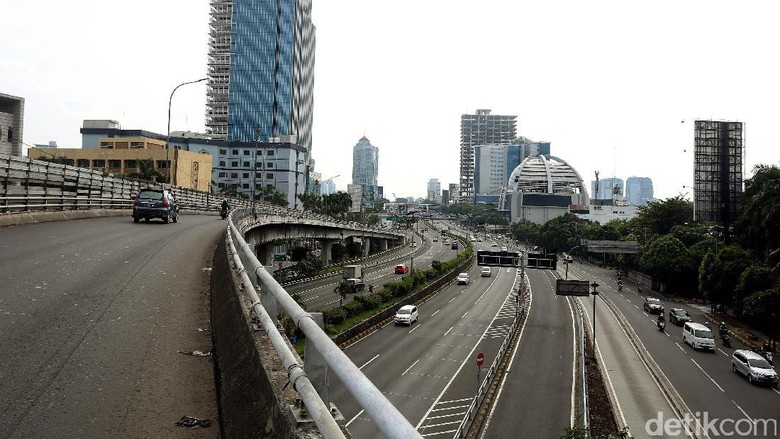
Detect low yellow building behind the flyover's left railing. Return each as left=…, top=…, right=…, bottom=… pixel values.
left=28, top=136, right=212, bottom=192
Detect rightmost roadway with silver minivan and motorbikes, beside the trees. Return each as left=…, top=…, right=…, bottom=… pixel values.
left=569, top=263, right=780, bottom=437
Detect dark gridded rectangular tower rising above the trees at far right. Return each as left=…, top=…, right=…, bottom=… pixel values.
left=693, top=120, right=745, bottom=234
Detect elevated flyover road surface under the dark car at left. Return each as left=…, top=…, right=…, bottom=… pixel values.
left=0, top=216, right=226, bottom=438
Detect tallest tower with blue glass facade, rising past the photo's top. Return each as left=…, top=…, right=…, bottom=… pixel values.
left=206, top=0, right=315, bottom=168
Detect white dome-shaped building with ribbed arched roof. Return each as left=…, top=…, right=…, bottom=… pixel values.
left=509, top=155, right=588, bottom=224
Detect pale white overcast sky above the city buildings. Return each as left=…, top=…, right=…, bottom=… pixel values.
left=0, top=0, right=780, bottom=198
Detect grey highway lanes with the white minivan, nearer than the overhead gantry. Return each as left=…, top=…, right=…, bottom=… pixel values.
left=330, top=241, right=518, bottom=438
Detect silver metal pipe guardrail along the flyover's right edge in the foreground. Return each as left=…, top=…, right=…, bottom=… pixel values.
left=229, top=211, right=422, bottom=439
